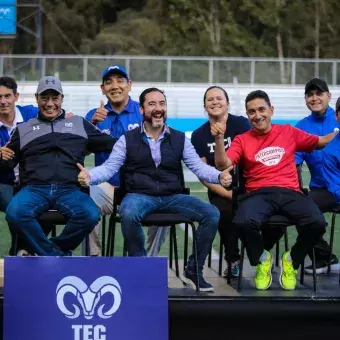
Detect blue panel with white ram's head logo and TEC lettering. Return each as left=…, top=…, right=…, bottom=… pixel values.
left=4, top=256, right=168, bottom=340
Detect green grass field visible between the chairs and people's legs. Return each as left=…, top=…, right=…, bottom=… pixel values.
left=0, top=156, right=340, bottom=257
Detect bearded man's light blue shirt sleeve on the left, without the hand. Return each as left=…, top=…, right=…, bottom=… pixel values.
left=89, top=135, right=126, bottom=185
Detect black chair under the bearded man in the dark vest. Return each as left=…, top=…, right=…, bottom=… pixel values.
left=103, top=168, right=199, bottom=292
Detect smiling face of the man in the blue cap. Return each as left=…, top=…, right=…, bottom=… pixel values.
left=100, top=73, right=131, bottom=106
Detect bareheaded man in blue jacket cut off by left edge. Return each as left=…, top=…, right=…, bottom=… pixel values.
left=0, top=77, right=38, bottom=212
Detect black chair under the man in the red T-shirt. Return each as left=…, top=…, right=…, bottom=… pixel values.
left=232, top=166, right=317, bottom=292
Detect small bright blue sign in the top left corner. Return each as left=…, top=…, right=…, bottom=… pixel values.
left=0, top=0, right=17, bottom=37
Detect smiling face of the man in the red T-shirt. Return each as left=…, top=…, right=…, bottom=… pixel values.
left=246, top=98, right=274, bottom=135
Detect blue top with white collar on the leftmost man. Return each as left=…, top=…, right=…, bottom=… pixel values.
left=0, top=105, right=39, bottom=184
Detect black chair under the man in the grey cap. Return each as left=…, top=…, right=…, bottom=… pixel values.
left=12, top=187, right=90, bottom=256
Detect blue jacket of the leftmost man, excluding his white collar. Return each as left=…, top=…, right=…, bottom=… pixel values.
left=0, top=105, right=39, bottom=185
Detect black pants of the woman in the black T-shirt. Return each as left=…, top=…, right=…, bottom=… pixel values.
left=209, top=195, right=240, bottom=262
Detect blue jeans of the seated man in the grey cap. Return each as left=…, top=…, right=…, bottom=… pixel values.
left=6, top=184, right=100, bottom=256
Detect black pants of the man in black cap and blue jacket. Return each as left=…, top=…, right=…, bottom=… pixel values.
left=297, top=188, right=337, bottom=264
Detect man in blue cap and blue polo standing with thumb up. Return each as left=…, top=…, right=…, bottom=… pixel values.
left=86, top=65, right=142, bottom=256
